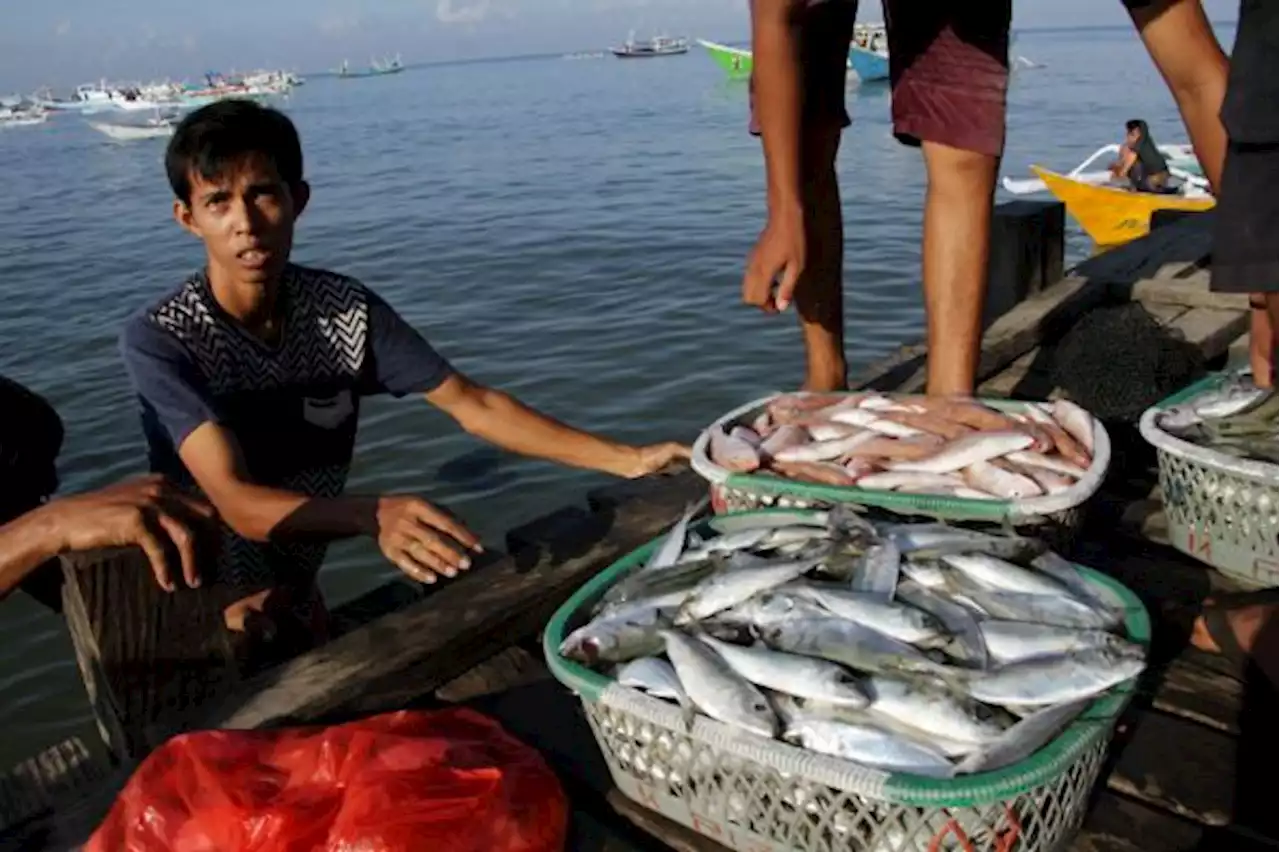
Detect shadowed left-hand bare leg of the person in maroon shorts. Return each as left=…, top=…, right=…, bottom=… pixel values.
left=795, top=127, right=849, bottom=391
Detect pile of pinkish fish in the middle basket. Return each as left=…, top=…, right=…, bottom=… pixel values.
left=708, top=393, right=1094, bottom=500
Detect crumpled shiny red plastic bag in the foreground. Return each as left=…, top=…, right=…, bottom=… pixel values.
left=84, top=709, right=568, bottom=852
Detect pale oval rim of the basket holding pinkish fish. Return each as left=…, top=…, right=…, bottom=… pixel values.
left=690, top=390, right=1111, bottom=522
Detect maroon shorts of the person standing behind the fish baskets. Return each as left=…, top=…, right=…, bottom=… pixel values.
left=750, top=0, right=1011, bottom=156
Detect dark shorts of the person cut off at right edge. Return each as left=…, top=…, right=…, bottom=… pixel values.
left=1212, top=142, right=1280, bottom=293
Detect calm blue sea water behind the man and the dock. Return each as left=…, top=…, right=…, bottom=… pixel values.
left=0, top=23, right=1230, bottom=766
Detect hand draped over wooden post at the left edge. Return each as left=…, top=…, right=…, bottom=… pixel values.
left=46, top=476, right=214, bottom=591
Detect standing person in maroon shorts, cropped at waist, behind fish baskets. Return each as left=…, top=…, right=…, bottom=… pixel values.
left=742, top=0, right=1011, bottom=394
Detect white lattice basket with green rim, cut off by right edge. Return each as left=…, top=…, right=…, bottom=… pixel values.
left=1138, top=370, right=1280, bottom=587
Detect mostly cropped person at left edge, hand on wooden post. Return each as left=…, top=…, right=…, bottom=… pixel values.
left=0, top=376, right=214, bottom=603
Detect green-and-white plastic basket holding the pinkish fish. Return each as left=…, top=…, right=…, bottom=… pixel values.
left=691, top=394, right=1111, bottom=530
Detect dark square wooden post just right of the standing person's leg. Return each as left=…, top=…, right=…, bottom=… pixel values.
left=983, top=200, right=1066, bottom=327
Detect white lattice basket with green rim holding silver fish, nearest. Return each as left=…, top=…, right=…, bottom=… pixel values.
left=543, top=512, right=1151, bottom=852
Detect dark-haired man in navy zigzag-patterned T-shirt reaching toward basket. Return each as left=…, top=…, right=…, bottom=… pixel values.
left=120, top=100, right=687, bottom=641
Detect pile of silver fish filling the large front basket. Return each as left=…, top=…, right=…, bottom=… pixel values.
left=559, top=507, right=1146, bottom=778
